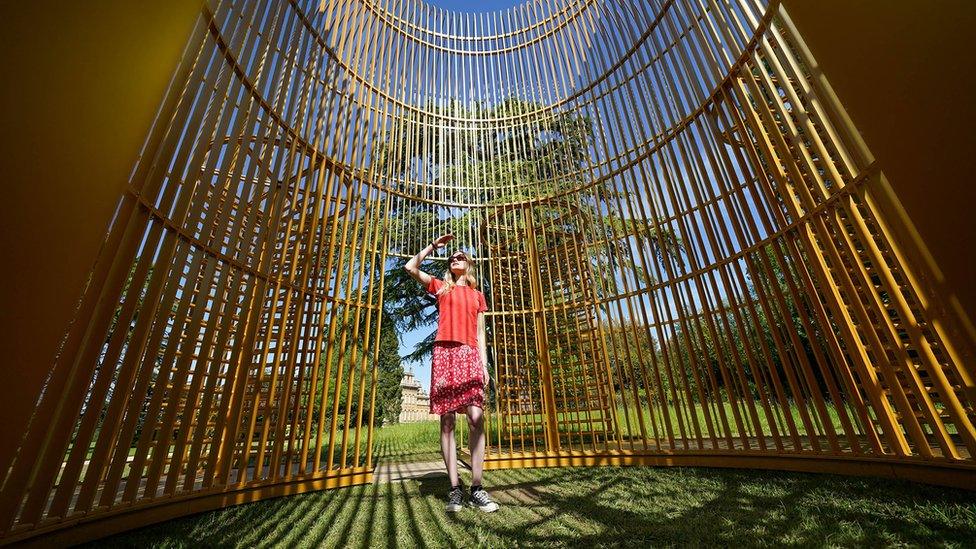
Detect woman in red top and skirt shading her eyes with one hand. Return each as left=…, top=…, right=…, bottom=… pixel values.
left=404, top=234, right=498, bottom=513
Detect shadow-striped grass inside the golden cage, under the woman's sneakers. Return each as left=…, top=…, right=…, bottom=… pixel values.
left=92, top=467, right=976, bottom=547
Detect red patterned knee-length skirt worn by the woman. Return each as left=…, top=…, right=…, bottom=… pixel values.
left=430, top=342, right=485, bottom=415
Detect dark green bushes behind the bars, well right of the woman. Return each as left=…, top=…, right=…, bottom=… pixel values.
left=609, top=244, right=829, bottom=402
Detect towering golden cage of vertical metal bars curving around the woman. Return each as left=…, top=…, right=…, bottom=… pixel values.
left=0, top=0, right=976, bottom=541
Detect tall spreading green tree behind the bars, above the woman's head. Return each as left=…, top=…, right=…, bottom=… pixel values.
left=373, top=98, right=683, bottom=366
